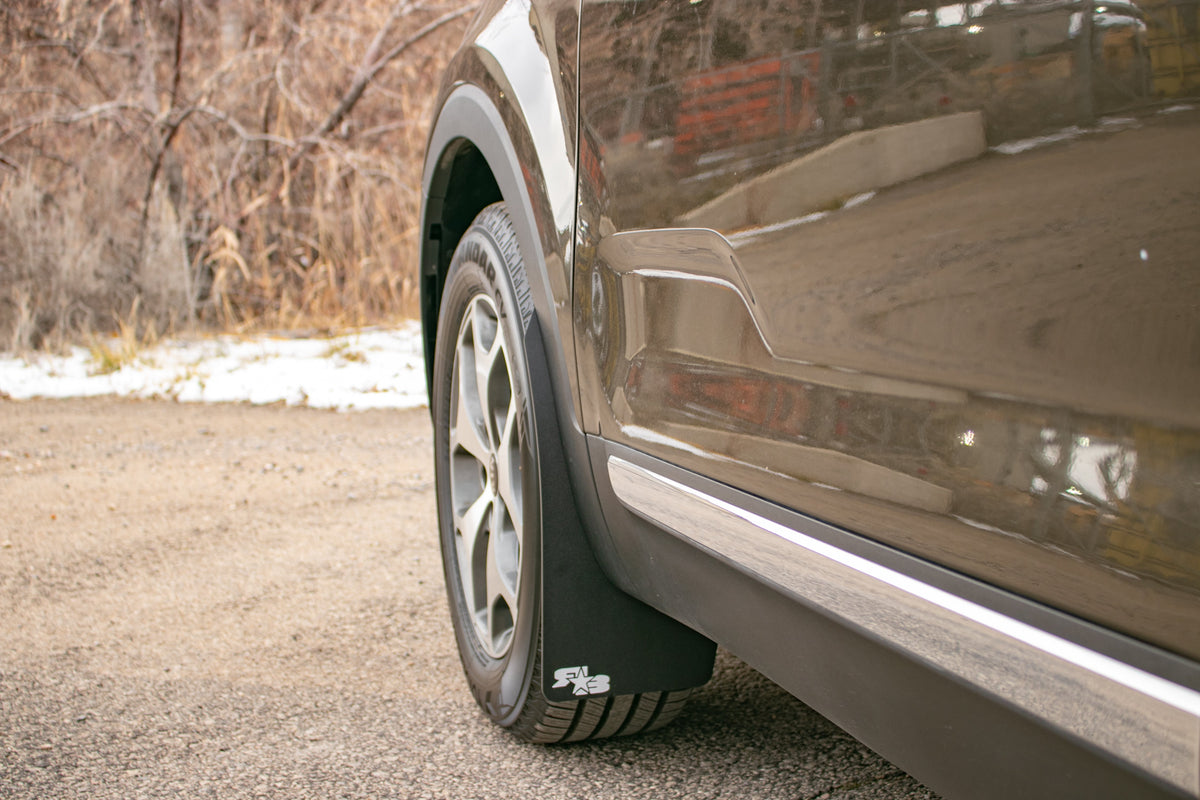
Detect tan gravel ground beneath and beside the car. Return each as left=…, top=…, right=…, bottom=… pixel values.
left=0, top=399, right=934, bottom=800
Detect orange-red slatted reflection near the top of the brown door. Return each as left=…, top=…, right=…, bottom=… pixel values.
left=674, top=52, right=821, bottom=160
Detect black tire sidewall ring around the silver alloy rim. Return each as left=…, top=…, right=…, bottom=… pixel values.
left=432, top=206, right=541, bottom=727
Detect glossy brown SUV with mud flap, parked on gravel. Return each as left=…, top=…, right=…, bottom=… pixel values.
left=421, top=0, right=1200, bottom=799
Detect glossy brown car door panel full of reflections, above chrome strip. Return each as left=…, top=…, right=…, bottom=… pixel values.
left=574, top=0, right=1200, bottom=657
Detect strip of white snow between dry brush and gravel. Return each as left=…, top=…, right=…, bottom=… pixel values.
left=0, top=323, right=426, bottom=410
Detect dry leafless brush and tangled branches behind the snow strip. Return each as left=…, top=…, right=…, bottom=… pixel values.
left=0, top=0, right=469, bottom=348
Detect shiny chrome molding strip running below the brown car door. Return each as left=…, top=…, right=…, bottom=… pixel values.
left=608, top=456, right=1200, bottom=796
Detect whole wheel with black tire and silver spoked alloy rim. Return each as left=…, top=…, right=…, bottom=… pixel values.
left=433, top=203, right=690, bottom=742
